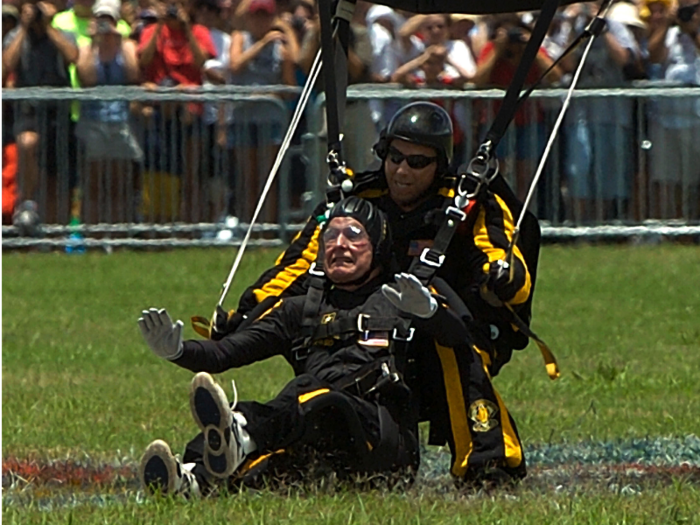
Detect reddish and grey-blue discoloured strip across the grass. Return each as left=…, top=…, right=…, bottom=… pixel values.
left=5, top=436, right=700, bottom=505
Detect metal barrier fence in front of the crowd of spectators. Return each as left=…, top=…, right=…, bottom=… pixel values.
left=0, top=84, right=700, bottom=249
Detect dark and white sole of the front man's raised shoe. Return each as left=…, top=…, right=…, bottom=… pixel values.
left=190, top=372, right=236, bottom=478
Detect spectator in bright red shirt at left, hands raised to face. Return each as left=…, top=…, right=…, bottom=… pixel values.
left=138, top=0, right=217, bottom=222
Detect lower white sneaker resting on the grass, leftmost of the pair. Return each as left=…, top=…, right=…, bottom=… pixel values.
left=139, top=439, right=201, bottom=498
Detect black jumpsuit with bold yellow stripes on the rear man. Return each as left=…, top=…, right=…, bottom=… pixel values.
left=230, top=172, right=531, bottom=480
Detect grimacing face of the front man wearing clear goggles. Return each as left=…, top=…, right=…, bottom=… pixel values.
left=323, top=217, right=372, bottom=284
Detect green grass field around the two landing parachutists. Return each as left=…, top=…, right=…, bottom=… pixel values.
left=0, top=245, right=700, bottom=524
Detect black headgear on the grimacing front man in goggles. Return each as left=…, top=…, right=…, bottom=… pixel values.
left=324, top=195, right=391, bottom=270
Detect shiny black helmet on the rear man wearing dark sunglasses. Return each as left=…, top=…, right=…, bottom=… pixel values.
left=374, top=102, right=454, bottom=172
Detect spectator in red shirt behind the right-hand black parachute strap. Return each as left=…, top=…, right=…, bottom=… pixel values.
left=472, top=14, right=561, bottom=199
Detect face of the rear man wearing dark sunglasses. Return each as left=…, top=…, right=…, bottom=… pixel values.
left=384, top=139, right=437, bottom=211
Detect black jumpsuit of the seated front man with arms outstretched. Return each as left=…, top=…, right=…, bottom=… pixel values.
left=174, top=278, right=468, bottom=486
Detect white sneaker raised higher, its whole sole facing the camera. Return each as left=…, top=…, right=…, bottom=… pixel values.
left=190, top=372, right=254, bottom=478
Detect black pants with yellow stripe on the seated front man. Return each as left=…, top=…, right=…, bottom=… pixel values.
left=184, top=374, right=419, bottom=486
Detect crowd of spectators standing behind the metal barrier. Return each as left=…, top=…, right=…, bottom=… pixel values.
left=0, top=0, right=700, bottom=229
